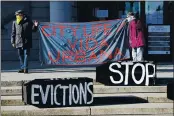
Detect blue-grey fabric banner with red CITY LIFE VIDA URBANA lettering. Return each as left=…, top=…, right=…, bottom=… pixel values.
left=39, top=19, right=130, bottom=65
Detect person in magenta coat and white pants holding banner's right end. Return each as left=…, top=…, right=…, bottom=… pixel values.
left=117, top=12, right=145, bottom=62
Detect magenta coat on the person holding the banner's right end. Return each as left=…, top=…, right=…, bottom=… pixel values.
left=129, top=19, right=145, bottom=48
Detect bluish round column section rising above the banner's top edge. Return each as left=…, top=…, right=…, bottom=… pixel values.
left=50, top=1, right=73, bottom=22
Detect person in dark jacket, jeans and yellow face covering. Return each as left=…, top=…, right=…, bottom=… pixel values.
left=11, top=10, right=38, bottom=73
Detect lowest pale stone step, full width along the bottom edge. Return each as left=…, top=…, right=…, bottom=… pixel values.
left=1, top=103, right=173, bottom=116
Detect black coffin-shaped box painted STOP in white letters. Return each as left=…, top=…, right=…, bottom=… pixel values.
left=96, top=62, right=156, bottom=86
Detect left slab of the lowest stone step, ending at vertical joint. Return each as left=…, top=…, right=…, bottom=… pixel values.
left=1, top=106, right=90, bottom=116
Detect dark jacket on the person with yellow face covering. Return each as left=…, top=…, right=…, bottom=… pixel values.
left=11, top=16, right=37, bottom=48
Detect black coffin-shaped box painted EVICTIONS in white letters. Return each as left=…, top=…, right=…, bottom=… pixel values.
left=22, top=78, right=93, bottom=108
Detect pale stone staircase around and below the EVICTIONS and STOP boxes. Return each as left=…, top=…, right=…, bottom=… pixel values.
left=1, top=64, right=174, bottom=116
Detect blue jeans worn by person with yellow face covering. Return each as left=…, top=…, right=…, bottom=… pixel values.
left=18, top=48, right=30, bottom=69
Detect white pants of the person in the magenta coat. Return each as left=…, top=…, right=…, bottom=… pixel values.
left=132, top=47, right=144, bottom=62
